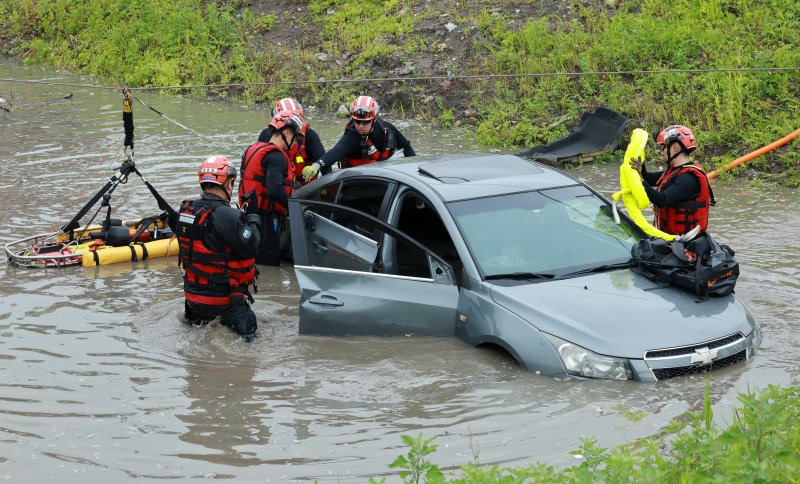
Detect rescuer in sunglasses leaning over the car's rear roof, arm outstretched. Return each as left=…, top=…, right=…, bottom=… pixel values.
left=303, top=96, right=416, bottom=178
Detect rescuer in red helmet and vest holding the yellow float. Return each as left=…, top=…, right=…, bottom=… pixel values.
left=631, top=124, right=715, bottom=235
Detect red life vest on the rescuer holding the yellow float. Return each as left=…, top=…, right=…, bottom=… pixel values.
left=653, top=163, right=714, bottom=235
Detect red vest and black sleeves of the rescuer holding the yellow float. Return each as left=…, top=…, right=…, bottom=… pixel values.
left=642, top=163, right=714, bottom=235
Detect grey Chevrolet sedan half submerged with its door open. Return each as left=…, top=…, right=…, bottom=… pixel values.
left=289, top=155, right=760, bottom=381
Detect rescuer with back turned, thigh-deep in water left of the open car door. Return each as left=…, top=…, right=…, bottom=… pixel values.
left=176, top=156, right=261, bottom=341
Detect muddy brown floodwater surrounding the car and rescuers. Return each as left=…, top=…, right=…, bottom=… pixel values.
left=0, top=60, right=800, bottom=483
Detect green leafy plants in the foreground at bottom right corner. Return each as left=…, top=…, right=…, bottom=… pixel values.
left=382, top=380, right=800, bottom=484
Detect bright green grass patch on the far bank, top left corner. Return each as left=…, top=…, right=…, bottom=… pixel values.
left=0, top=0, right=253, bottom=87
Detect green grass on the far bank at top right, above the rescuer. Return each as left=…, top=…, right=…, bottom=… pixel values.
left=474, top=0, right=800, bottom=177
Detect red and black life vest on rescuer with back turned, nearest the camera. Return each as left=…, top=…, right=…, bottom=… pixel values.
left=177, top=200, right=256, bottom=306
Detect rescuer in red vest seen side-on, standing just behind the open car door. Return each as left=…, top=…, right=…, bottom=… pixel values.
left=239, top=111, right=303, bottom=266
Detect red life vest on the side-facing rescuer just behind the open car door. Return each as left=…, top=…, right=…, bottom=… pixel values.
left=239, top=141, right=295, bottom=213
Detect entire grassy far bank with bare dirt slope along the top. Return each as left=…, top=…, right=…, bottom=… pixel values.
left=0, top=0, right=800, bottom=186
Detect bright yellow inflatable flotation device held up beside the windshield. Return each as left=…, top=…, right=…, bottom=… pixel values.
left=612, top=128, right=675, bottom=242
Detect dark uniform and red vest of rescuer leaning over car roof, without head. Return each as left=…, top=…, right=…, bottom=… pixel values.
left=318, top=119, right=416, bottom=171
